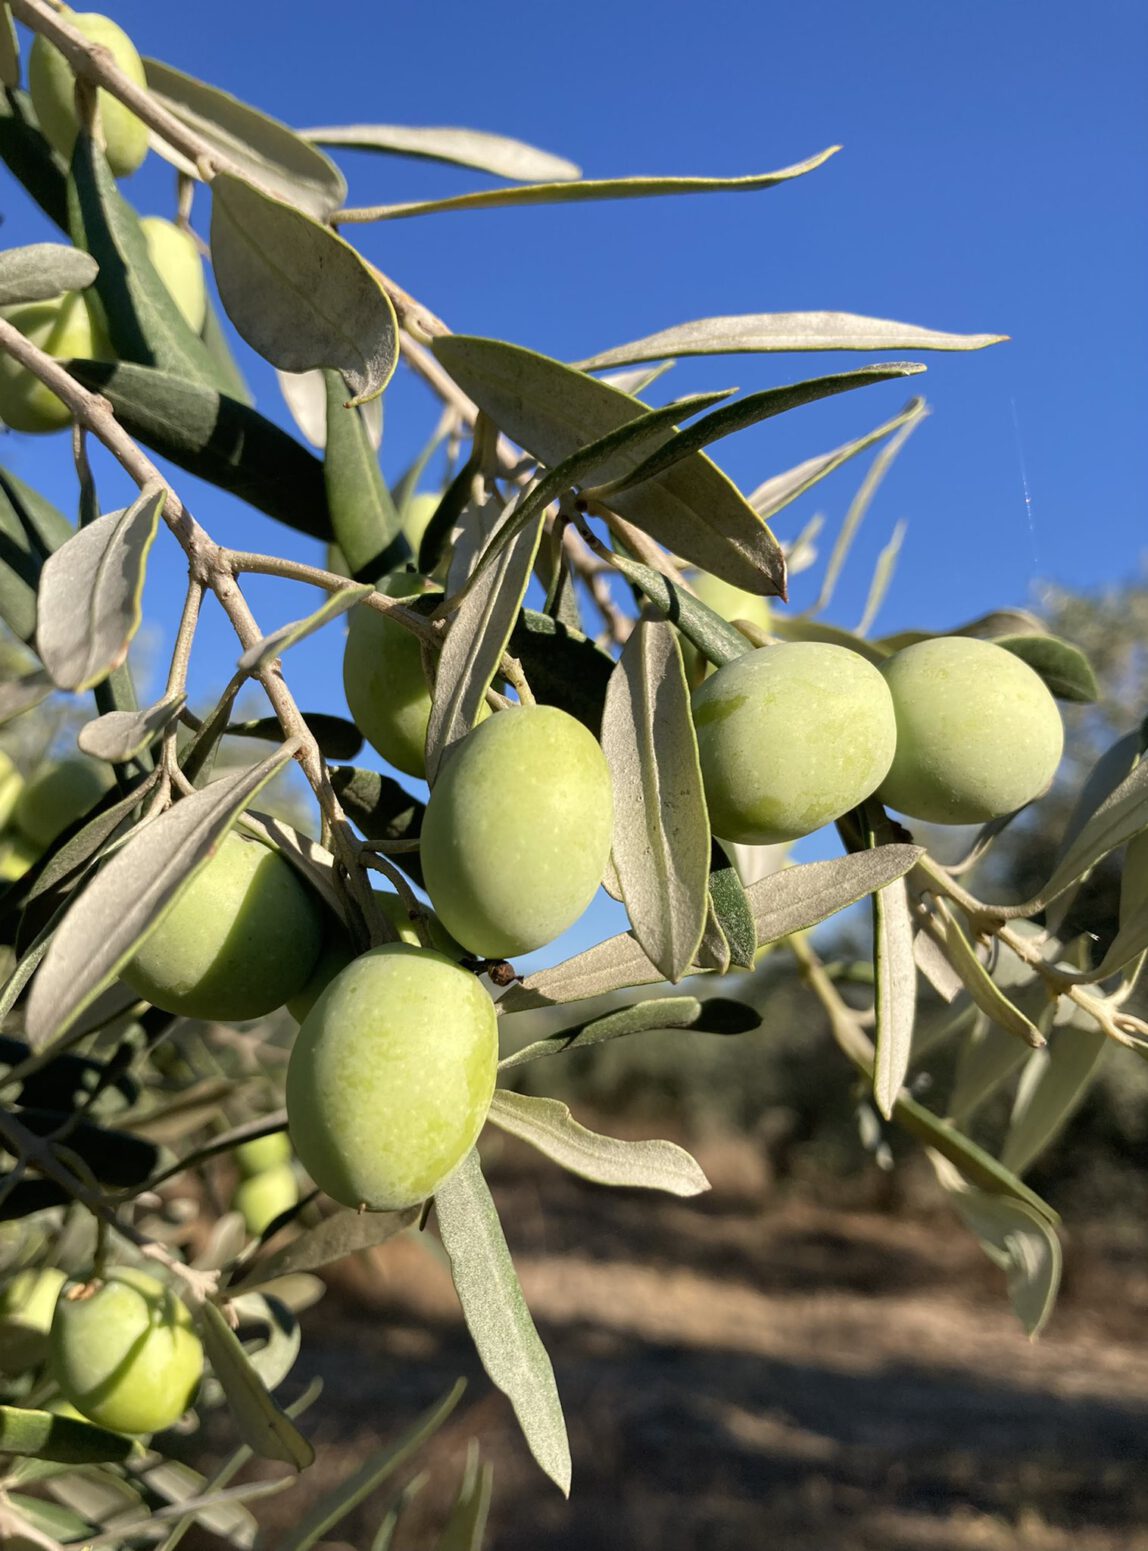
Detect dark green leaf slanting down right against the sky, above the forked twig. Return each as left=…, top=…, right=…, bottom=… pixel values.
left=68, top=361, right=332, bottom=541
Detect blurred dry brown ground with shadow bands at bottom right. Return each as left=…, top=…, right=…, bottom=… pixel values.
left=232, top=1145, right=1148, bottom=1551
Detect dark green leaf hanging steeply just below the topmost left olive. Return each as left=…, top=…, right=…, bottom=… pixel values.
left=68, top=133, right=223, bottom=388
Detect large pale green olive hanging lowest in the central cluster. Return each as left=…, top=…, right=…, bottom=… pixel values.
left=287, top=943, right=498, bottom=1211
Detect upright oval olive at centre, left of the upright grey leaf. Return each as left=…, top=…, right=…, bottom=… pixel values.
left=419, top=706, right=614, bottom=959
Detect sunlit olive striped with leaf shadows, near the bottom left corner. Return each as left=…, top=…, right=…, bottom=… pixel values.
left=50, top=1266, right=203, bottom=1433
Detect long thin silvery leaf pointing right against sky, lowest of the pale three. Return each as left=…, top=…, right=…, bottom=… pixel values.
left=577, top=312, right=1008, bottom=372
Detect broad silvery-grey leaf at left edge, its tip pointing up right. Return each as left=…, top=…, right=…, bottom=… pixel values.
left=36, top=485, right=166, bottom=690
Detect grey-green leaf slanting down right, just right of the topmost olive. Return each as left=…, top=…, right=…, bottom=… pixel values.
left=144, top=59, right=348, bottom=220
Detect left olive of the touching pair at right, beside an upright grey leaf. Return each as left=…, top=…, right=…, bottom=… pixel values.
left=693, top=641, right=897, bottom=845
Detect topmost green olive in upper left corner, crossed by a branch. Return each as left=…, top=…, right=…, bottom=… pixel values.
left=28, top=11, right=147, bottom=178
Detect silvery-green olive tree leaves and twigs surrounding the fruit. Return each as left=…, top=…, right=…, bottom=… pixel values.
left=0, top=0, right=1148, bottom=1548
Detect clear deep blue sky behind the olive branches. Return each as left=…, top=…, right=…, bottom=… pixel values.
left=2, top=0, right=1148, bottom=967
